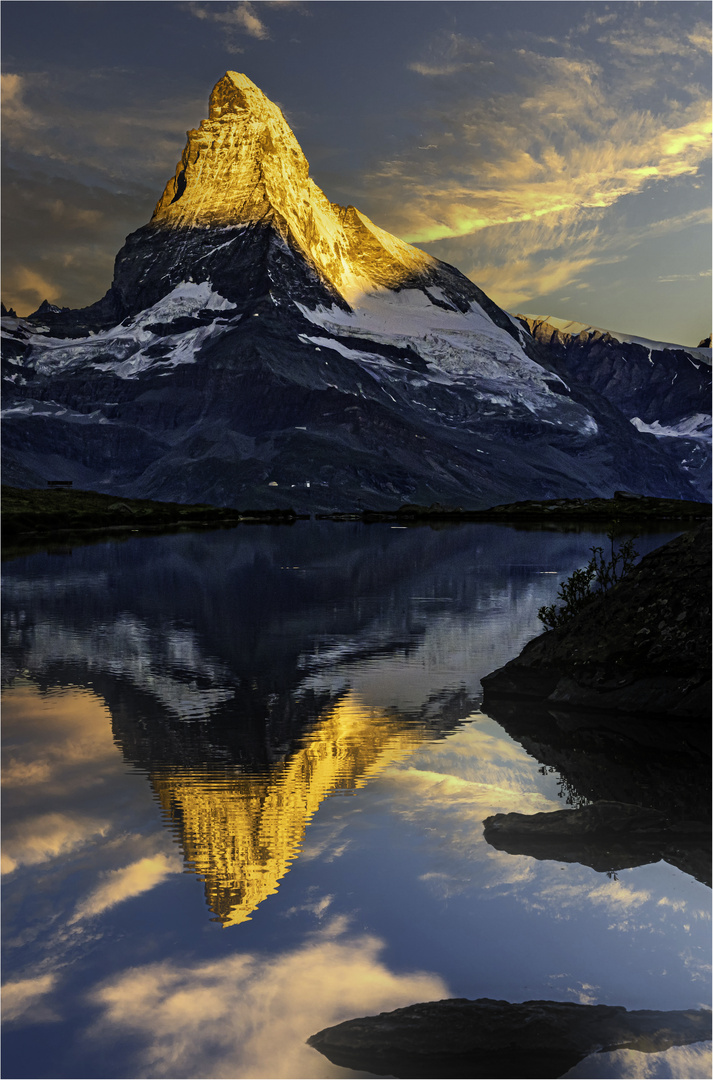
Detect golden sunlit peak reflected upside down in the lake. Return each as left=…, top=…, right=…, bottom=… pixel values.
left=150, top=693, right=428, bottom=927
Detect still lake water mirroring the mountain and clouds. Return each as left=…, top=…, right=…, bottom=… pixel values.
left=2, top=523, right=710, bottom=1078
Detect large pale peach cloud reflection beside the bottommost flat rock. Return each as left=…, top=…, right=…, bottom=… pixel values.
left=91, top=920, right=449, bottom=1080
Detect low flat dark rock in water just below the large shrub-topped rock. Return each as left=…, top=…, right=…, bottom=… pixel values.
left=483, top=801, right=711, bottom=886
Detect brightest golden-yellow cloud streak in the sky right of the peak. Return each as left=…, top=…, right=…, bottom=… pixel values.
left=373, top=95, right=710, bottom=243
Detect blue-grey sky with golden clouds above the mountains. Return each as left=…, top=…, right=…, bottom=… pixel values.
left=2, top=0, right=711, bottom=346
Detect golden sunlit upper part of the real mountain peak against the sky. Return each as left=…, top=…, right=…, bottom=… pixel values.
left=151, top=71, right=435, bottom=301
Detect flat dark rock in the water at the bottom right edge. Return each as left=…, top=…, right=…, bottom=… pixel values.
left=308, top=998, right=711, bottom=1080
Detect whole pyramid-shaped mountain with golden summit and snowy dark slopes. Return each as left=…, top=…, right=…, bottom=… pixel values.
left=3, top=72, right=703, bottom=510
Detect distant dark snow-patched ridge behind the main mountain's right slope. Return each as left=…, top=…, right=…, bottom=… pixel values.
left=517, top=315, right=711, bottom=499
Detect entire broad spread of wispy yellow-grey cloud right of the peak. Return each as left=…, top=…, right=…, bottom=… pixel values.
left=364, top=14, right=710, bottom=315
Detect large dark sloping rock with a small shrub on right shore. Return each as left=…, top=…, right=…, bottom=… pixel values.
left=483, top=525, right=711, bottom=719
